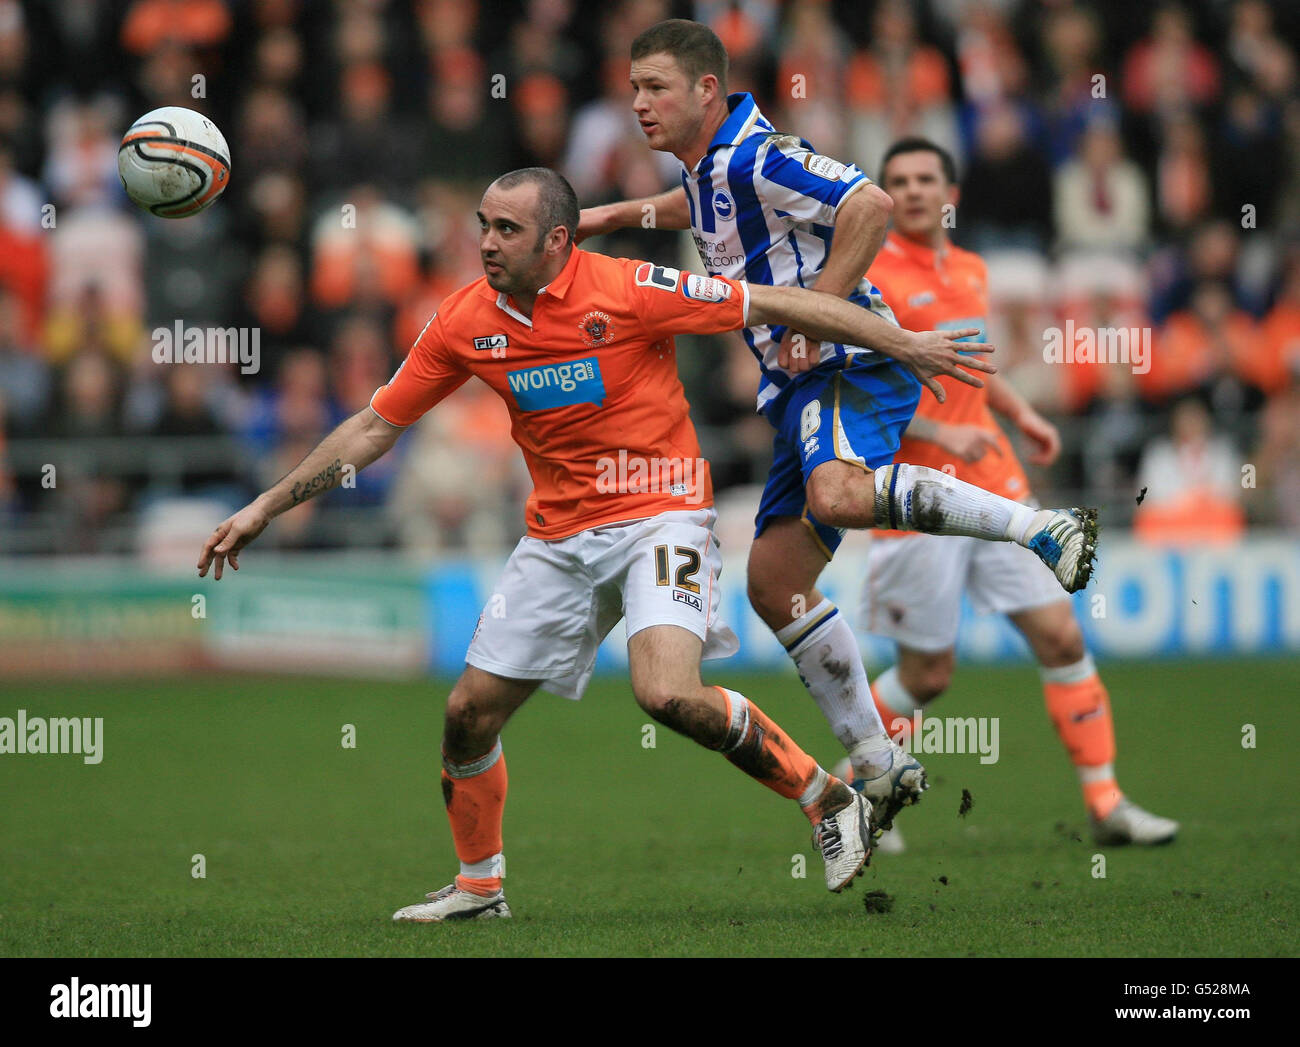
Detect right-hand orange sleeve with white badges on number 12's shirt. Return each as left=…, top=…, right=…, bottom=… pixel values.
left=629, top=261, right=749, bottom=341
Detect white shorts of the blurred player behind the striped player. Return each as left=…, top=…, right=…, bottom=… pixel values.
left=859, top=535, right=1069, bottom=652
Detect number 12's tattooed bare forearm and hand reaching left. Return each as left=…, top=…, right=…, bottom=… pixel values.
left=198, top=406, right=403, bottom=581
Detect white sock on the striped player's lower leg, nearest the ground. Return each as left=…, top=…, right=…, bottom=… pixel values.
left=776, top=600, right=889, bottom=750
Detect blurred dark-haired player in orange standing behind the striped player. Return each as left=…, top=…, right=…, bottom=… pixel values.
left=862, top=138, right=1178, bottom=852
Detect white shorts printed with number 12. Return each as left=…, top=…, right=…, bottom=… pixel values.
left=465, top=509, right=740, bottom=698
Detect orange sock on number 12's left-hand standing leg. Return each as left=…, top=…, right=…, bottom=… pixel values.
left=442, top=741, right=507, bottom=895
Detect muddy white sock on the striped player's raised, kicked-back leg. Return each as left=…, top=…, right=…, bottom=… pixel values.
left=875, top=462, right=1037, bottom=545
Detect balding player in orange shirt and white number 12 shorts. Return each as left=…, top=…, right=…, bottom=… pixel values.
left=198, top=168, right=980, bottom=922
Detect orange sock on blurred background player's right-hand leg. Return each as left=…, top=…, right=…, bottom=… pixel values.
left=1041, top=654, right=1123, bottom=818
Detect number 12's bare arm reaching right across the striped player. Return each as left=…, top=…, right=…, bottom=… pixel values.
left=745, top=284, right=997, bottom=403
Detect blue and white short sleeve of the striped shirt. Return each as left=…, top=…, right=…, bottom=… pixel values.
left=754, top=134, right=871, bottom=225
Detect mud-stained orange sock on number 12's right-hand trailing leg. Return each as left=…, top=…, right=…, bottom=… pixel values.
left=718, top=687, right=852, bottom=825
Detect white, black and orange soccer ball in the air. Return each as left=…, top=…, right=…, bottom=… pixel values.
left=117, top=105, right=230, bottom=219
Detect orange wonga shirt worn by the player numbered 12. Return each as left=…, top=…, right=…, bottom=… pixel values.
left=371, top=248, right=749, bottom=540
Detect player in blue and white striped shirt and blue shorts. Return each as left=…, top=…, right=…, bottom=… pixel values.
left=579, top=20, right=1096, bottom=827
